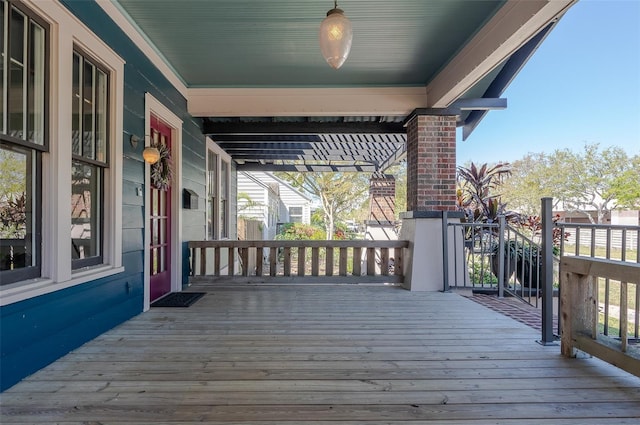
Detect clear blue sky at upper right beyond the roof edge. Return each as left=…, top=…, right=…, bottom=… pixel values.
left=457, top=0, right=640, bottom=164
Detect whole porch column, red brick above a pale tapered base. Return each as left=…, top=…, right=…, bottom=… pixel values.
left=400, top=109, right=462, bottom=291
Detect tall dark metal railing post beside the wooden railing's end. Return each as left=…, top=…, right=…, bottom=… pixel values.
left=540, top=198, right=556, bottom=345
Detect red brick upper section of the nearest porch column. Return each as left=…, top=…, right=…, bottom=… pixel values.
left=407, top=115, right=456, bottom=211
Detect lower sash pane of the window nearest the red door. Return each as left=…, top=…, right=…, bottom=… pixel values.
left=71, top=161, right=102, bottom=260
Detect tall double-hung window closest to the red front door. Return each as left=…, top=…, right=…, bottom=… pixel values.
left=71, top=52, right=108, bottom=269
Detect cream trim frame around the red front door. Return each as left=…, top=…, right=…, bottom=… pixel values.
left=143, top=93, right=182, bottom=311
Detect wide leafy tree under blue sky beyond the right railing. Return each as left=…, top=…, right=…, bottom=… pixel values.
left=502, top=144, right=640, bottom=223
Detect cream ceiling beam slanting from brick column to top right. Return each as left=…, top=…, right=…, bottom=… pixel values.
left=427, top=0, right=577, bottom=108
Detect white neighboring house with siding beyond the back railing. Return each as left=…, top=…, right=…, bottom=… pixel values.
left=237, top=171, right=311, bottom=239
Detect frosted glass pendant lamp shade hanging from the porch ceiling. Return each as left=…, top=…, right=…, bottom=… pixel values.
left=320, top=7, right=353, bottom=69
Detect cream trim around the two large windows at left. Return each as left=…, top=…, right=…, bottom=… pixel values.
left=0, top=0, right=125, bottom=306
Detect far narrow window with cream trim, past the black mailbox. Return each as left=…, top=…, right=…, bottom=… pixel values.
left=206, top=139, right=231, bottom=240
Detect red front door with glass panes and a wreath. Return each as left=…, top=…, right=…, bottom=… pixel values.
left=149, top=115, right=171, bottom=302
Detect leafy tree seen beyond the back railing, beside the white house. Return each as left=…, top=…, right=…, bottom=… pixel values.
left=278, top=172, right=369, bottom=239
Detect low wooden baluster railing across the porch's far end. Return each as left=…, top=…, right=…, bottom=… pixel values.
left=189, top=240, right=409, bottom=283
